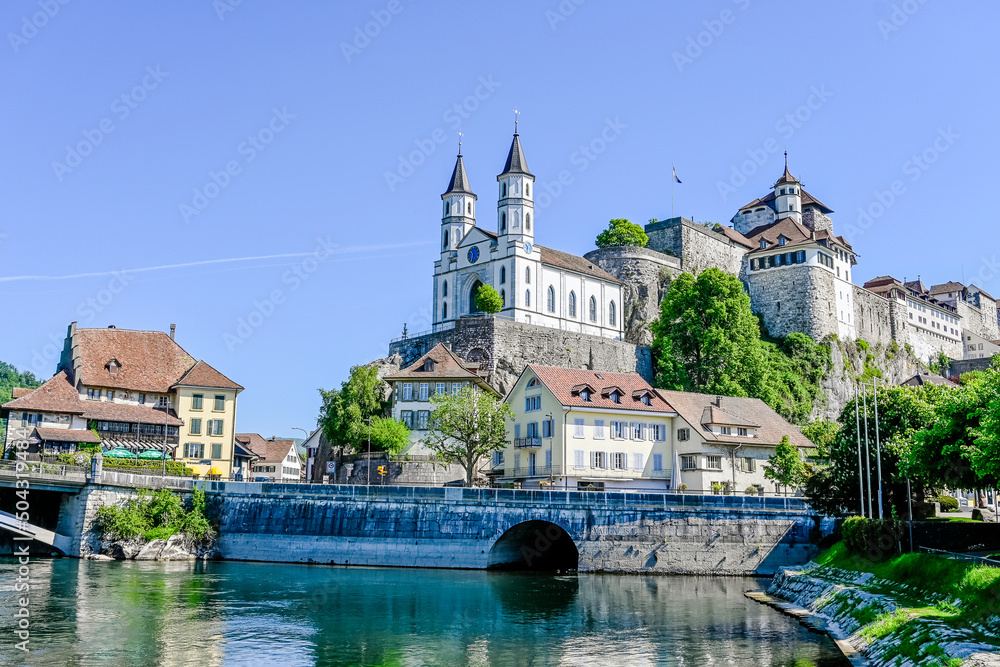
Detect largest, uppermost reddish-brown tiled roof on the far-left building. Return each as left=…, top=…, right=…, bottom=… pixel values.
left=74, top=329, right=195, bottom=393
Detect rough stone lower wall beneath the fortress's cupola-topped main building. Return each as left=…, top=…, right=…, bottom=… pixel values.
left=747, top=265, right=838, bottom=341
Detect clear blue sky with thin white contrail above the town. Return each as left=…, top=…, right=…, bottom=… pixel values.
left=0, top=0, right=1000, bottom=436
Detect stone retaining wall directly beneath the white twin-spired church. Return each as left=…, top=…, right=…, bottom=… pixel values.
left=389, top=317, right=653, bottom=394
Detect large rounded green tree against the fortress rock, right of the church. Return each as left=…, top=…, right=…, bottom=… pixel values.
left=651, top=268, right=773, bottom=400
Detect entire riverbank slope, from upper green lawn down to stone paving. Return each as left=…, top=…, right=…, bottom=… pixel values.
left=760, top=544, right=1000, bottom=667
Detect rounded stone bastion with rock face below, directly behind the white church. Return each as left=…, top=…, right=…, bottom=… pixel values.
left=584, top=246, right=681, bottom=346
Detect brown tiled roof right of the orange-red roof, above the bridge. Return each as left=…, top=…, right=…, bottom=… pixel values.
left=656, top=389, right=816, bottom=447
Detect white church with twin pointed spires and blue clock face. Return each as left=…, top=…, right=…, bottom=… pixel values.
left=433, top=124, right=623, bottom=339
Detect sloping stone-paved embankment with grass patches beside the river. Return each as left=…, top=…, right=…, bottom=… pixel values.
left=748, top=563, right=1000, bottom=667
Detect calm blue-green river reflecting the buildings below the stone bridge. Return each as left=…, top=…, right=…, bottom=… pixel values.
left=0, top=558, right=847, bottom=667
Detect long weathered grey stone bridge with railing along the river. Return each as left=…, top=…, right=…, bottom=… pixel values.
left=0, top=472, right=828, bottom=574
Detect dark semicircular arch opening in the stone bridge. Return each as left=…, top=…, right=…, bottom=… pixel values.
left=486, top=520, right=580, bottom=572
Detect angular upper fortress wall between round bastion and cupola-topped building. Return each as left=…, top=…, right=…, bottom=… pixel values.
left=645, top=218, right=747, bottom=276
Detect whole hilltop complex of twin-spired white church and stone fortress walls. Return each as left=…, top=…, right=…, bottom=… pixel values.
left=390, top=129, right=1000, bottom=413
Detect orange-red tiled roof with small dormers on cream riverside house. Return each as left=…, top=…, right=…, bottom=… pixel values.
left=525, top=364, right=674, bottom=412
